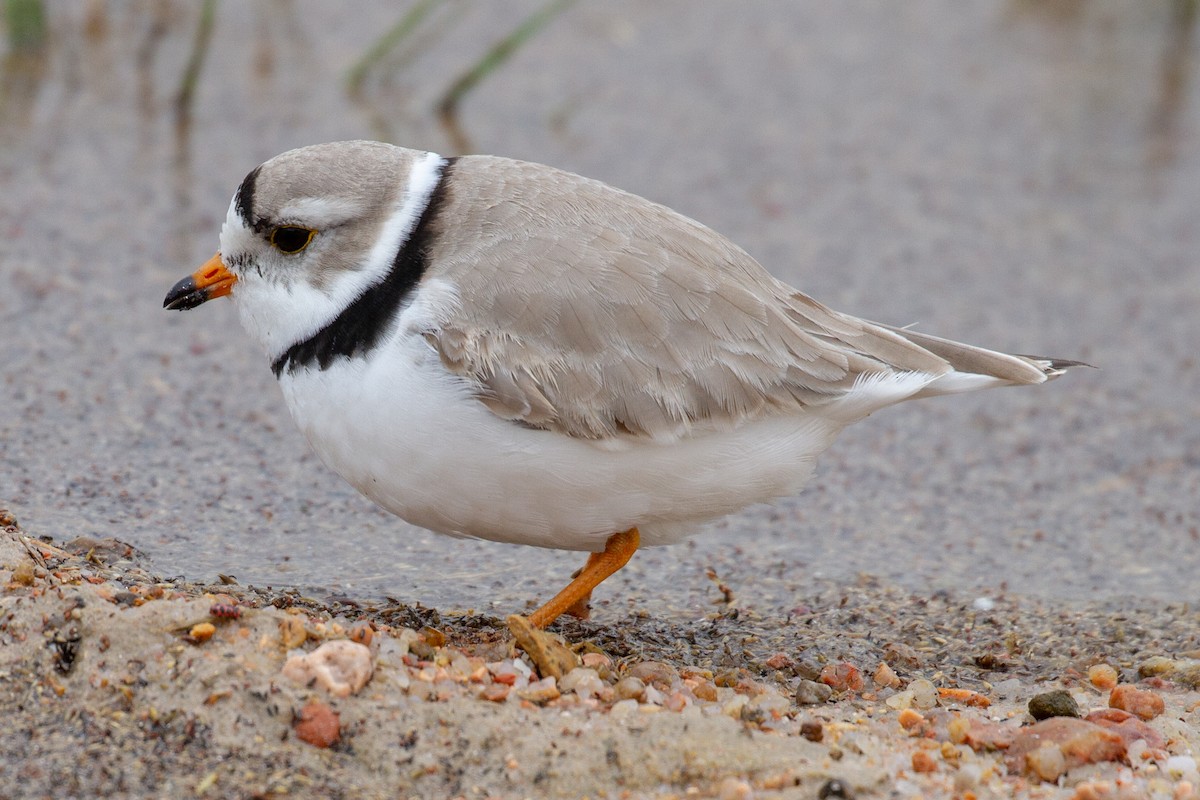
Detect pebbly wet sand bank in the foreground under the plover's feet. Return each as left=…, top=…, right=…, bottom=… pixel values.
left=0, top=512, right=1200, bottom=800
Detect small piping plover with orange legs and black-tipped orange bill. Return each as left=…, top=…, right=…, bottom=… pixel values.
left=164, top=142, right=1078, bottom=627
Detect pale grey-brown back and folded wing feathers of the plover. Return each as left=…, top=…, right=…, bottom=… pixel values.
left=425, top=156, right=949, bottom=439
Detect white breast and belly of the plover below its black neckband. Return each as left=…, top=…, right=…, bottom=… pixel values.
left=280, top=336, right=841, bottom=551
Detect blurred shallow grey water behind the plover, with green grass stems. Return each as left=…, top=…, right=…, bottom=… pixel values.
left=0, top=0, right=1200, bottom=618
